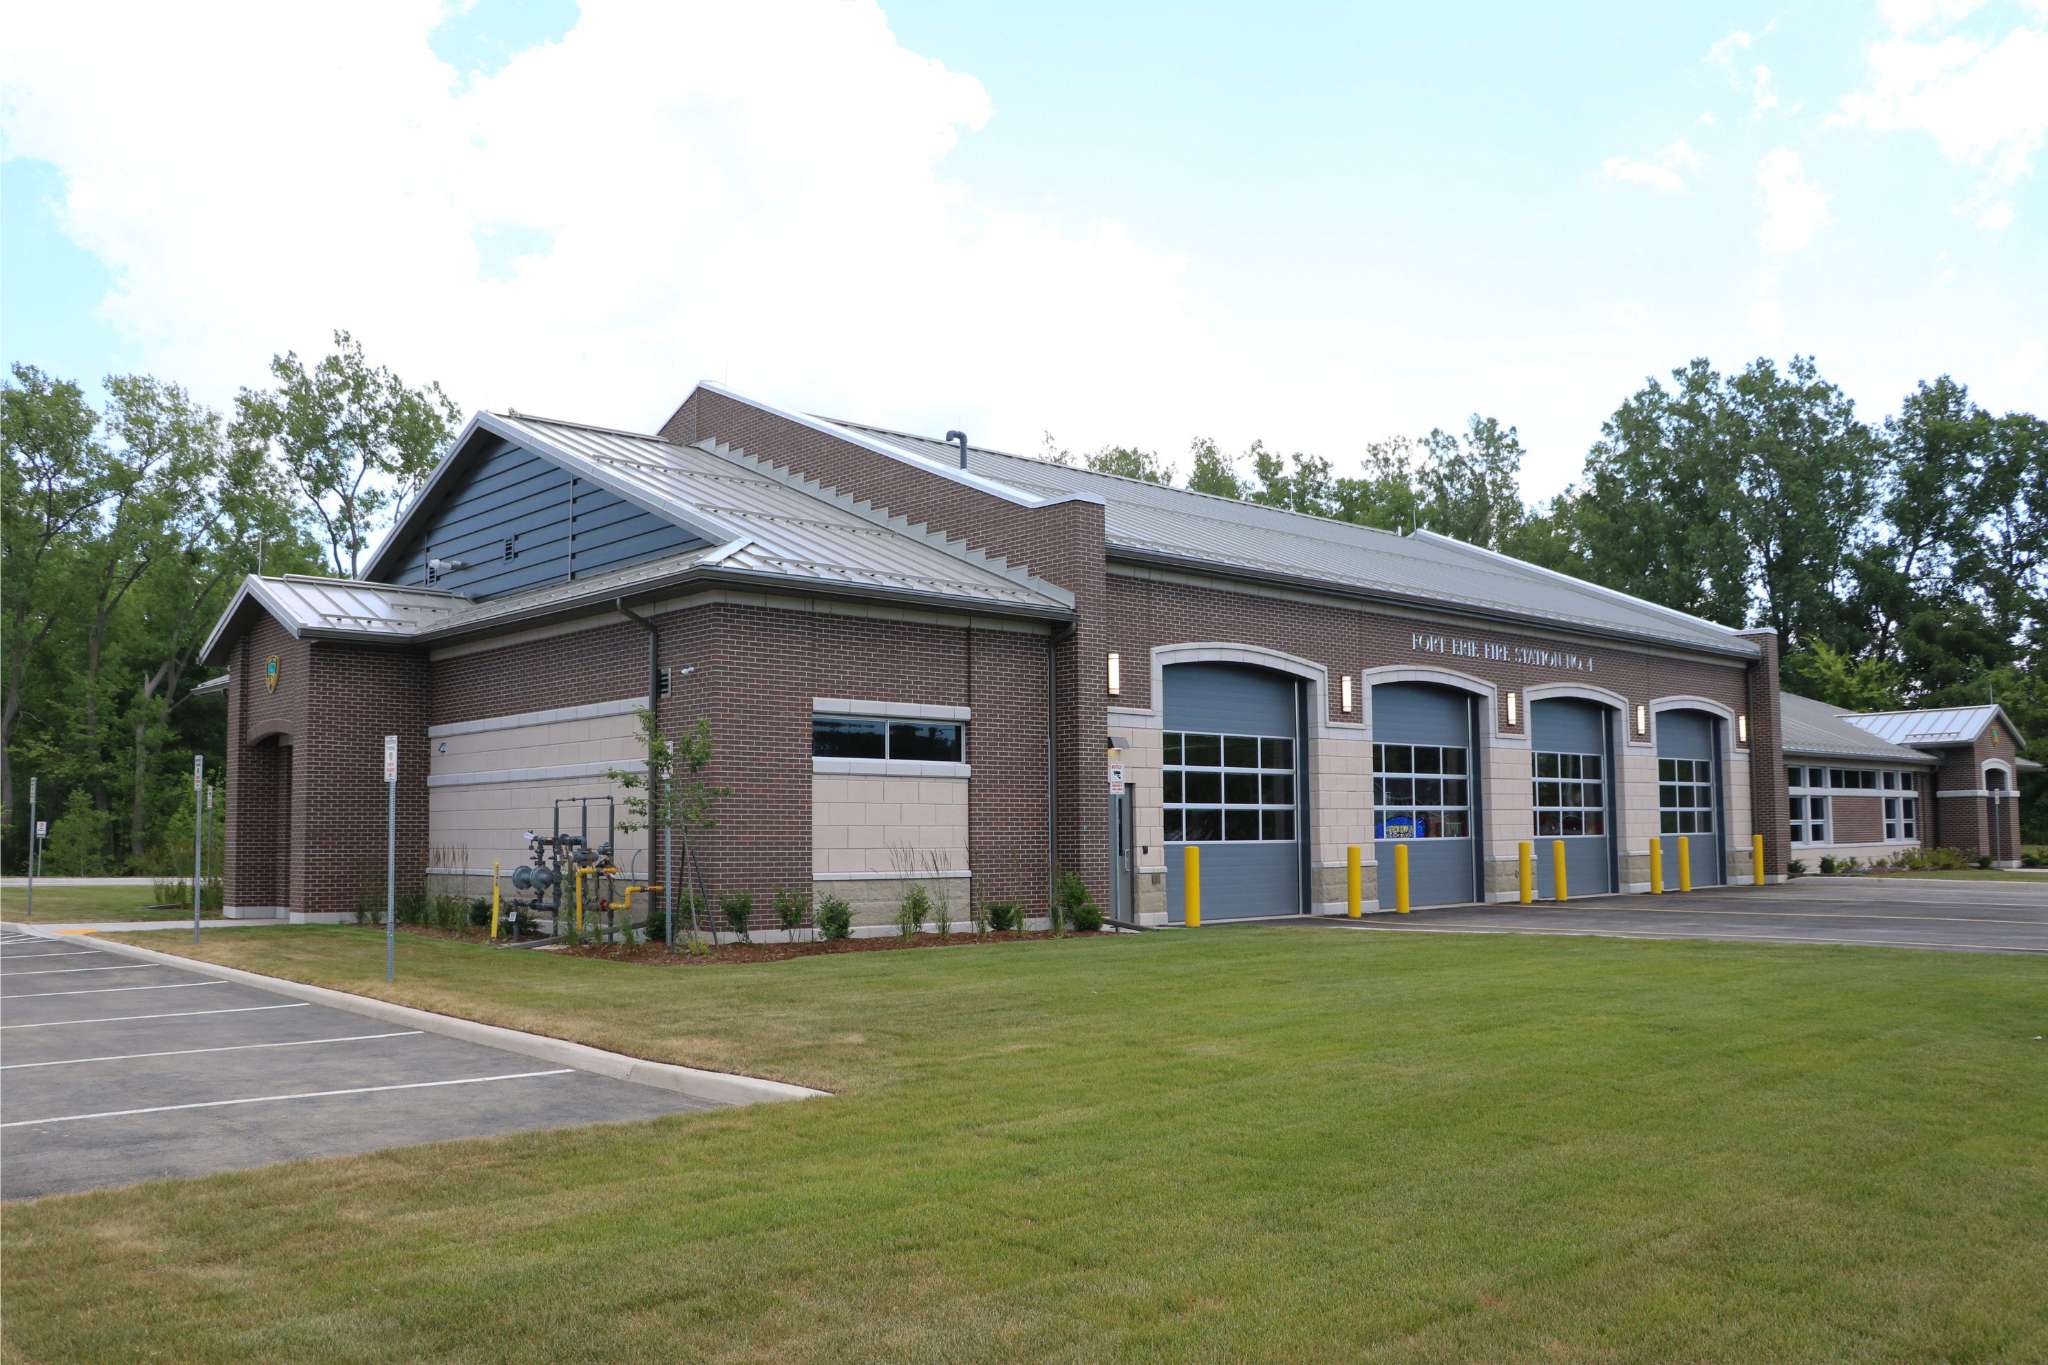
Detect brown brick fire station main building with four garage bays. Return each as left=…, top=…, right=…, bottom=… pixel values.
left=205, top=385, right=2015, bottom=927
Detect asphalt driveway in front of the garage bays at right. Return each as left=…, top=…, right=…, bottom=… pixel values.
left=1266, top=876, right=2048, bottom=954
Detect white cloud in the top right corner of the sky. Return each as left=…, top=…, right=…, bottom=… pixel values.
left=1829, top=6, right=2048, bottom=197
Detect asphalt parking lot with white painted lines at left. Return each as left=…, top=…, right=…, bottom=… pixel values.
left=0, top=925, right=713, bottom=1199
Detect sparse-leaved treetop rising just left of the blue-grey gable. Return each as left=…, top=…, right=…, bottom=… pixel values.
left=233, top=332, right=461, bottom=579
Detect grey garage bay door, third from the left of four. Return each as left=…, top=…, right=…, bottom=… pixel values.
left=1530, top=698, right=1614, bottom=898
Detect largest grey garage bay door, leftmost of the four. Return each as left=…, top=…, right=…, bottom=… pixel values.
left=1159, top=663, right=1305, bottom=923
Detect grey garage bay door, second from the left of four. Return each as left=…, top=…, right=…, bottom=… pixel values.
left=1372, top=684, right=1479, bottom=909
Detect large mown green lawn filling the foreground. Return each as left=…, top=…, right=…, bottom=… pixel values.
left=4, top=927, right=2048, bottom=1365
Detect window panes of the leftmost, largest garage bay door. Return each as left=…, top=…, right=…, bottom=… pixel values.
left=1159, top=731, right=1294, bottom=843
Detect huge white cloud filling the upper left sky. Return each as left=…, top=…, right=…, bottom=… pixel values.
left=0, top=0, right=1231, bottom=444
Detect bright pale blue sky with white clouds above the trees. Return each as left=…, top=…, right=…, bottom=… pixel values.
left=0, top=0, right=2048, bottom=499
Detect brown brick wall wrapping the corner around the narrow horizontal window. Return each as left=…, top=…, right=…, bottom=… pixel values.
left=430, top=598, right=1064, bottom=927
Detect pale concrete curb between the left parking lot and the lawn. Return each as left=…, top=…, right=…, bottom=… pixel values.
left=48, top=935, right=829, bottom=1105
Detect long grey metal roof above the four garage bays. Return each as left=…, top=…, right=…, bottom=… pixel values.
left=815, top=413, right=1759, bottom=659
